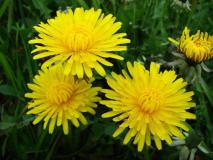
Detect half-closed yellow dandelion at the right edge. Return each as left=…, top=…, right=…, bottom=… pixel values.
left=169, top=27, right=213, bottom=63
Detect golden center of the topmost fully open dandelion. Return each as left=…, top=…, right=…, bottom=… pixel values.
left=64, top=26, right=93, bottom=53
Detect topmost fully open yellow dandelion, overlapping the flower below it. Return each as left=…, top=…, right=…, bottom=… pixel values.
left=29, top=8, right=130, bottom=78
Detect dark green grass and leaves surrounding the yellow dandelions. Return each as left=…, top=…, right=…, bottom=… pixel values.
left=0, top=0, right=213, bottom=160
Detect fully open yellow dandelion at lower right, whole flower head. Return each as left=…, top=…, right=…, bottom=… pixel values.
left=101, top=62, right=195, bottom=151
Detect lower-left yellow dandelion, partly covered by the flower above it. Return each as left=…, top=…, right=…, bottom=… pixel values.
left=25, top=65, right=100, bottom=134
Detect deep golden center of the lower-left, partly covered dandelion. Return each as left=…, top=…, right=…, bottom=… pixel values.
left=47, top=83, right=73, bottom=105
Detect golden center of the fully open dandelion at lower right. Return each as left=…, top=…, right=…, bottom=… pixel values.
left=138, top=90, right=163, bottom=114
